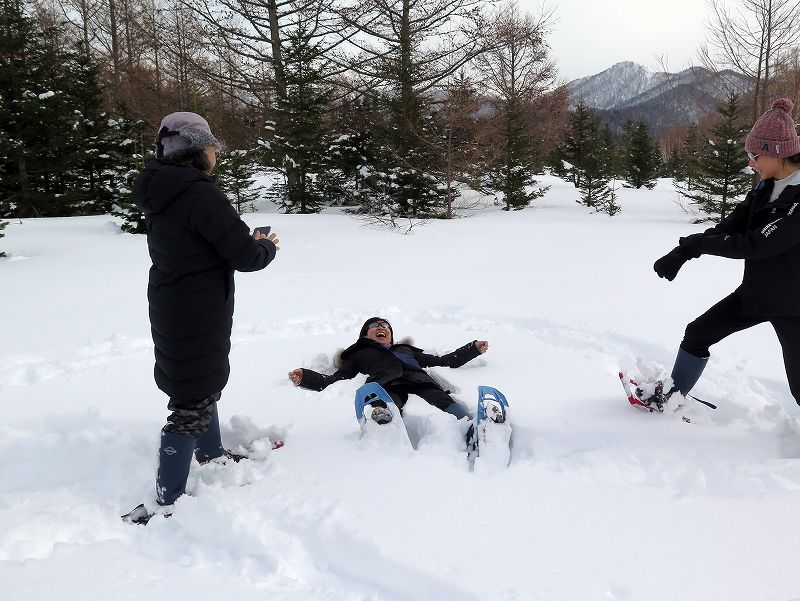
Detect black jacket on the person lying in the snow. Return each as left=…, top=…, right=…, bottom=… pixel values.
left=300, top=338, right=481, bottom=390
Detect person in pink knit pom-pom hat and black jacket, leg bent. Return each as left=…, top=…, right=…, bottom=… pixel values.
left=648, top=98, right=800, bottom=408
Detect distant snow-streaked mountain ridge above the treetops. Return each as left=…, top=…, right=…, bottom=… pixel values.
left=567, top=61, right=751, bottom=134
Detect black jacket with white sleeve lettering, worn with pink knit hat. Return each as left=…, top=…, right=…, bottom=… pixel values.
left=700, top=179, right=800, bottom=317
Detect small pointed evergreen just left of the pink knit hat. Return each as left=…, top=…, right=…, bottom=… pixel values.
left=679, top=92, right=751, bottom=220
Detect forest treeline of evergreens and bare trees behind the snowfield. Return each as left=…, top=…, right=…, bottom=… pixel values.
left=0, top=0, right=800, bottom=236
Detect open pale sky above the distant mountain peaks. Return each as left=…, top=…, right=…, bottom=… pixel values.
left=518, top=0, right=708, bottom=81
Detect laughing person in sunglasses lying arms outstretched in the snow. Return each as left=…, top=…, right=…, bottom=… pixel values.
left=289, top=317, right=489, bottom=423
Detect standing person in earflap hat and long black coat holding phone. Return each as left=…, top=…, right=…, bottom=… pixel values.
left=122, top=112, right=278, bottom=523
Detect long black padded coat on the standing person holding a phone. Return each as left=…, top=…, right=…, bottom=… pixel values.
left=133, top=159, right=276, bottom=401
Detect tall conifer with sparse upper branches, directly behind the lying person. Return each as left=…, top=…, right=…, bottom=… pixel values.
left=334, top=0, right=484, bottom=223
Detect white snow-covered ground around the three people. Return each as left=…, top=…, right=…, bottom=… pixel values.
left=0, top=178, right=800, bottom=601
